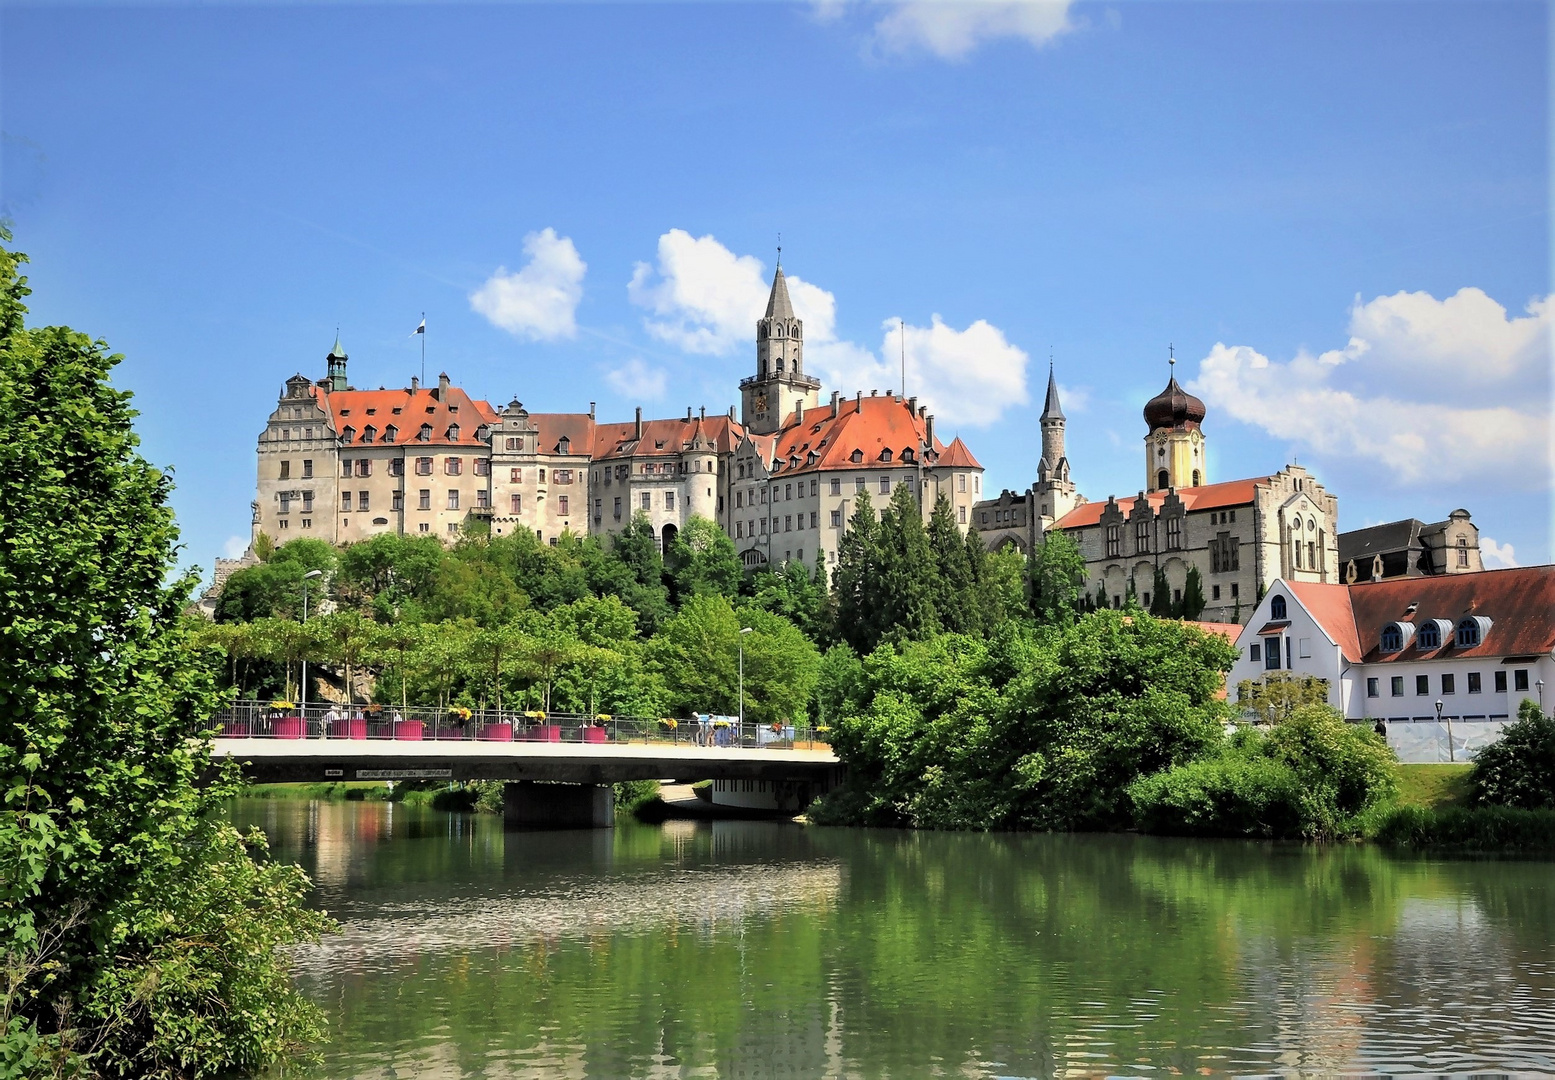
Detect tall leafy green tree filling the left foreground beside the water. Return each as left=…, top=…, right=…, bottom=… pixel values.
left=0, top=232, right=328, bottom=1077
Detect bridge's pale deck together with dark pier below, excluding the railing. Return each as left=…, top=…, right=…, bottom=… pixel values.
left=213, top=737, right=840, bottom=827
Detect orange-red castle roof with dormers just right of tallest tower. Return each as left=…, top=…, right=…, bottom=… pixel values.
left=753, top=393, right=957, bottom=472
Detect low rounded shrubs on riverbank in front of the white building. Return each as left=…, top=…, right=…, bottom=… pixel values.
left=1129, top=704, right=1398, bottom=841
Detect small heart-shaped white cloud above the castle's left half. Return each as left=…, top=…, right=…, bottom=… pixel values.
left=470, top=228, right=588, bottom=340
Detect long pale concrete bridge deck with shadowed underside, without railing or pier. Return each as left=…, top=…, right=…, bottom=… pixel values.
left=213, top=738, right=841, bottom=785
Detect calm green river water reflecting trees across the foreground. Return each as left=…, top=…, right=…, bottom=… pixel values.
left=233, top=800, right=1555, bottom=1080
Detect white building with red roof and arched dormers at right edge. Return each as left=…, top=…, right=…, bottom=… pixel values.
left=1227, top=566, right=1555, bottom=761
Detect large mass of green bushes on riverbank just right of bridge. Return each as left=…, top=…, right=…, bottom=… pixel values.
left=810, top=611, right=1233, bottom=830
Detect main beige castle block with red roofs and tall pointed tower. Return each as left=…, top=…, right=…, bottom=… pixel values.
left=252, top=266, right=983, bottom=569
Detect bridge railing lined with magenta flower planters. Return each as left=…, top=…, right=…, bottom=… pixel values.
left=211, top=701, right=829, bottom=749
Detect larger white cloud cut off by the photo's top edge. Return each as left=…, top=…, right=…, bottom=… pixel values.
left=871, top=0, right=1075, bottom=61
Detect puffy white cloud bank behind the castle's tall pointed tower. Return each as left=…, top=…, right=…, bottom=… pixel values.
left=627, top=228, right=1029, bottom=426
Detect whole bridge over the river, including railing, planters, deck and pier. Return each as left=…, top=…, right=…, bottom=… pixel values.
left=211, top=709, right=841, bottom=828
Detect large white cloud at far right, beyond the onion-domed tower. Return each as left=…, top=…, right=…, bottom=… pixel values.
left=1188, top=289, right=1555, bottom=488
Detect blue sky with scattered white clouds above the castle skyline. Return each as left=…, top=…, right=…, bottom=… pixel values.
left=0, top=0, right=1555, bottom=569
